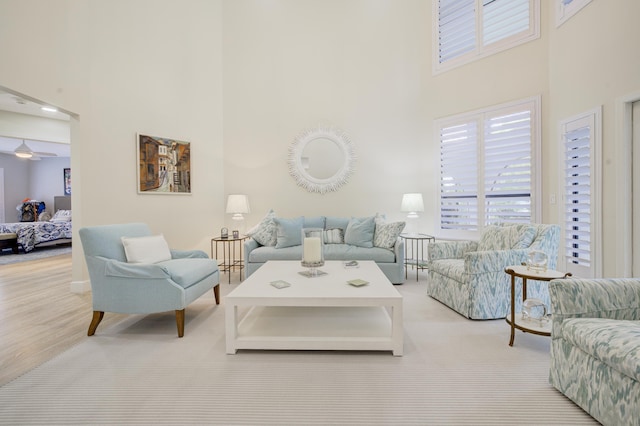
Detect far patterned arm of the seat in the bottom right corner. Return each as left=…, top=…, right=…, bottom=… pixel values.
left=549, top=278, right=640, bottom=321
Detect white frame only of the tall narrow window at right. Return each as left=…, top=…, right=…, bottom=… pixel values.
left=558, top=106, right=602, bottom=278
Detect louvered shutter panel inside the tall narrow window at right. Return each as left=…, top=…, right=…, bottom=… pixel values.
left=564, top=119, right=592, bottom=268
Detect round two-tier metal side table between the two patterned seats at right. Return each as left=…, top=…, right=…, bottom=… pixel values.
left=504, top=264, right=571, bottom=346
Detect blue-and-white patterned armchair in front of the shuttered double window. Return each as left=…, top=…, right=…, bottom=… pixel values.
left=427, top=224, right=560, bottom=319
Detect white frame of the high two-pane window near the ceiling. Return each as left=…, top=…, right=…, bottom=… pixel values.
left=431, top=0, right=540, bottom=75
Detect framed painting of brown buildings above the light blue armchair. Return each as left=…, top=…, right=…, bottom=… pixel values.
left=136, top=134, right=191, bottom=194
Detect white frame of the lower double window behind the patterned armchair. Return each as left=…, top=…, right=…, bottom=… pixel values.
left=434, top=95, right=542, bottom=240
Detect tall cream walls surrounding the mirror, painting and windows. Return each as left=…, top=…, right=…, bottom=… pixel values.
left=0, top=0, right=640, bottom=277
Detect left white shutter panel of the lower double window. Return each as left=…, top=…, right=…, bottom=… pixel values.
left=440, top=121, right=478, bottom=230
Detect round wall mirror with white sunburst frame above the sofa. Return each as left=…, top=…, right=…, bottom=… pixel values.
left=288, top=127, right=355, bottom=194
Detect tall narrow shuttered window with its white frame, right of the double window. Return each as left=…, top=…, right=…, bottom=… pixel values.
left=561, top=110, right=601, bottom=278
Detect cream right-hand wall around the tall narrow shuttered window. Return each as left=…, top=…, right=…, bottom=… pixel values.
left=544, top=0, right=640, bottom=277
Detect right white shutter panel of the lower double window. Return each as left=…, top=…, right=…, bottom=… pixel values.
left=484, top=110, right=532, bottom=225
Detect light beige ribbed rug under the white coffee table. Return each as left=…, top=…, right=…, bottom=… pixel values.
left=0, top=280, right=597, bottom=425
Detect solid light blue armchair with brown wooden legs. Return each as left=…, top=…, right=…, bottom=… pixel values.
left=79, top=223, right=220, bottom=337
